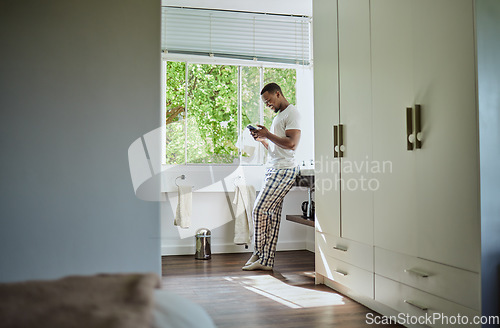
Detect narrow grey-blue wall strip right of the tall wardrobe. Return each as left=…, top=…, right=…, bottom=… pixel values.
left=476, top=0, right=500, bottom=327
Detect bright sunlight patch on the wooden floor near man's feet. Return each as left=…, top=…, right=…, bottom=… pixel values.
left=225, top=275, right=344, bottom=309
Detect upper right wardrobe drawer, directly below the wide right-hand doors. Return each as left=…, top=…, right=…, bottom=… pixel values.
left=375, top=247, right=480, bottom=310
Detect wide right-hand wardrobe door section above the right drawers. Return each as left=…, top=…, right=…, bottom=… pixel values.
left=372, top=0, right=480, bottom=272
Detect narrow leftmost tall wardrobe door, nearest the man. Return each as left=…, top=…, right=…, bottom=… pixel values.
left=313, top=0, right=340, bottom=236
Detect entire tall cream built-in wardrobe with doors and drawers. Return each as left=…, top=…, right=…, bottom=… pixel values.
left=313, top=0, right=498, bottom=322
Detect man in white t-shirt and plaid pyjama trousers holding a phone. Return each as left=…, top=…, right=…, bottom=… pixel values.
left=243, top=83, right=300, bottom=271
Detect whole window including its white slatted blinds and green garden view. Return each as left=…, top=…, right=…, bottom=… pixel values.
left=161, top=6, right=311, bottom=165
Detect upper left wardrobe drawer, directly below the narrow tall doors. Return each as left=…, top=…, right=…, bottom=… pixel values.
left=316, top=232, right=373, bottom=272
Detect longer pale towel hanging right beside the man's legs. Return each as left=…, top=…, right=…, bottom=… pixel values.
left=233, top=185, right=255, bottom=244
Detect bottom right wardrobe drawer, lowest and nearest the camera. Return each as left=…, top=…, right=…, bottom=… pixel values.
left=375, top=274, right=481, bottom=327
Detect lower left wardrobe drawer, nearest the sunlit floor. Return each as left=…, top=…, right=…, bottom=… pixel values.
left=316, top=253, right=374, bottom=299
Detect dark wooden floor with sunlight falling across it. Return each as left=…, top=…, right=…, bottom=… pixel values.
left=162, top=251, right=402, bottom=328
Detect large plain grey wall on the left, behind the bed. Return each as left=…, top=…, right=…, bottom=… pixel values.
left=0, top=0, right=160, bottom=281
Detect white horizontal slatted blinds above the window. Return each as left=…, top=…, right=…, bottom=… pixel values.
left=162, top=7, right=311, bottom=65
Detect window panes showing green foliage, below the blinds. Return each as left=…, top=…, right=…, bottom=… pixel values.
left=164, top=61, right=296, bottom=165
